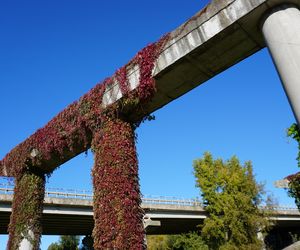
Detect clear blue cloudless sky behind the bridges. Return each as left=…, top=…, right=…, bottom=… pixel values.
left=0, top=0, right=297, bottom=250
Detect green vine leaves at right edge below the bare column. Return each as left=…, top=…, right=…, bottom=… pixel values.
left=286, top=123, right=300, bottom=210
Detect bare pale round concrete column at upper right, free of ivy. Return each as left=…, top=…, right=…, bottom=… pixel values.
left=262, top=4, right=300, bottom=126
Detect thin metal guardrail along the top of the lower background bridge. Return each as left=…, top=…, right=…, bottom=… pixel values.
left=0, top=183, right=298, bottom=211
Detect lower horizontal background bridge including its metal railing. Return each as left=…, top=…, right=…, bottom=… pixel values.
left=0, top=186, right=300, bottom=235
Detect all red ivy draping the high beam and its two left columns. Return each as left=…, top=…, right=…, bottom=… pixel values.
left=0, top=33, right=169, bottom=250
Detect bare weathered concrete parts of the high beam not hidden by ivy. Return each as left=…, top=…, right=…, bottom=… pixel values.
left=0, top=0, right=300, bottom=175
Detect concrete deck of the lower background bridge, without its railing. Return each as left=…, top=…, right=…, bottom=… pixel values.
left=0, top=195, right=300, bottom=235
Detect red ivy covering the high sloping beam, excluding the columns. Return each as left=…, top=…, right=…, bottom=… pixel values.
left=0, top=36, right=168, bottom=179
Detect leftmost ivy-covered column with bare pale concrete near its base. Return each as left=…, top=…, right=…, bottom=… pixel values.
left=7, top=171, right=45, bottom=250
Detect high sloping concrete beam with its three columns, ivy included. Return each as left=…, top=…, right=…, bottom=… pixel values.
left=0, top=0, right=300, bottom=249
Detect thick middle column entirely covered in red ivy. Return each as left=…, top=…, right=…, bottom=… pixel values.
left=92, top=118, right=145, bottom=250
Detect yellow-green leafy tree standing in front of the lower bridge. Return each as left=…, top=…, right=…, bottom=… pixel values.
left=193, top=153, right=269, bottom=250
